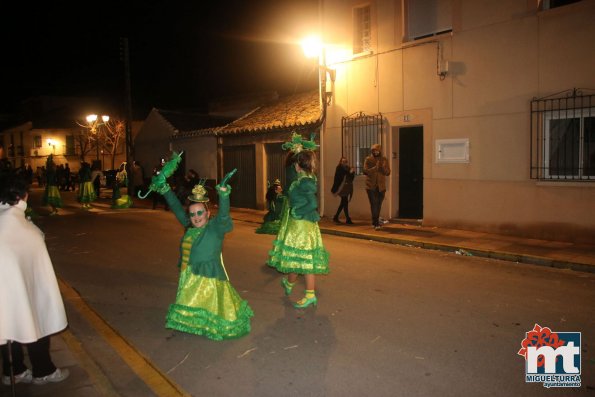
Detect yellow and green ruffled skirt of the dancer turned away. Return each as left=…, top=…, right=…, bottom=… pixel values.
left=267, top=216, right=329, bottom=274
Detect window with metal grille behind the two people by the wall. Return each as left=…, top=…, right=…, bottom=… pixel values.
left=337, top=112, right=382, bottom=175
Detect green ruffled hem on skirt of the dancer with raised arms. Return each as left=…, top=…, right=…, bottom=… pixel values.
left=165, top=301, right=254, bottom=341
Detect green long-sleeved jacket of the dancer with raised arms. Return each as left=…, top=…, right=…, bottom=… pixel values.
left=163, top=186, right=233, bottom=280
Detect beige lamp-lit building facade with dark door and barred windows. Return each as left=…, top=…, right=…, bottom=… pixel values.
left=321, top=0, right=595, bottom=242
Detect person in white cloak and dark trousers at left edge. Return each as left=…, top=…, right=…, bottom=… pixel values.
left=0, top=171, right=69, bottom=385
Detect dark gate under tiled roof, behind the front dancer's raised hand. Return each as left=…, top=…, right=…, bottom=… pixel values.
left=223, top=145, right=256, bottom=209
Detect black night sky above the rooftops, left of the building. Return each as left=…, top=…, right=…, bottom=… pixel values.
left=0, top=0, right=318, bottom=118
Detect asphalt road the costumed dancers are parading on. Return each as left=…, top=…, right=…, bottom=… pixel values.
left=31, top=193, right=595, bottom=397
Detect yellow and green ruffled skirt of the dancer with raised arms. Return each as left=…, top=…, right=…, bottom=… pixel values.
left=165, top=267, right=254, bottom=340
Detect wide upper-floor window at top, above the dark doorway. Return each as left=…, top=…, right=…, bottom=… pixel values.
left=404, top=0, right=452, bottom=40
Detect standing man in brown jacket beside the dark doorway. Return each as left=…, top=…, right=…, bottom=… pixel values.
left=364, top=143, right=390, bottom=230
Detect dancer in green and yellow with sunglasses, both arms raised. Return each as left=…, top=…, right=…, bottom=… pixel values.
left=151, top=158, right=254, bottom=340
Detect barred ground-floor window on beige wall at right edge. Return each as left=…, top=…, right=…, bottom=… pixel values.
left=531, top=88, right=595, bottom=181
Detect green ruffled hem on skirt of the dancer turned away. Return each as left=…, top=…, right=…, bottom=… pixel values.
left=267, top=240, right=330, bottom=274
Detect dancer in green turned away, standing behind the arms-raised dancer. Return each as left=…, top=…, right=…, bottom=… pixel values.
left=267, top=135, right=329, bottom=308
